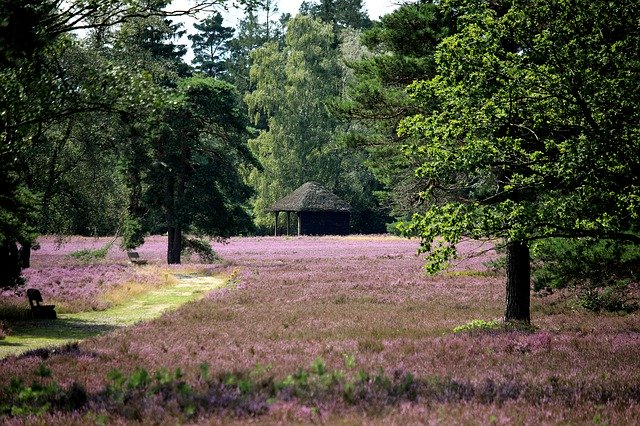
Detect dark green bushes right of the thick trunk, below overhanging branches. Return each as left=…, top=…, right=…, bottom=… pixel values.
left=532, top=238, right=640, bottom=312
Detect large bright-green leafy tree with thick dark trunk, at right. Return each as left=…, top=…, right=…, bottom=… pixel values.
left=401, top=0, right=640, bottom=322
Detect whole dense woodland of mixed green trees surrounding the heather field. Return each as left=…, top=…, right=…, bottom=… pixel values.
left=0, top=0, right=640, bottom=322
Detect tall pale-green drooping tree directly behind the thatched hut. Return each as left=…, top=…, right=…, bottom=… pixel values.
left=245, top=15, right=384, bottom=232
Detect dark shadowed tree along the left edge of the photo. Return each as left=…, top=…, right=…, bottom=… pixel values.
left=0, top=1, right=74, bottom=287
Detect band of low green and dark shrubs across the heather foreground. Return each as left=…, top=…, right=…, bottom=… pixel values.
left=0, top=356, right=640, bottom=423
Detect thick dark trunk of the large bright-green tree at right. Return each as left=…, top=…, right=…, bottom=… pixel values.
left=504, top=241, right=531, bottom=323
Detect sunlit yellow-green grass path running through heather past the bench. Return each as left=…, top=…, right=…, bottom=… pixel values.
left=0, top=275, right=225, bottom=359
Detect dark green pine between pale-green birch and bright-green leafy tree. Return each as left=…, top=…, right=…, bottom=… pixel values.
left=332, top=1, right=455, bottom=220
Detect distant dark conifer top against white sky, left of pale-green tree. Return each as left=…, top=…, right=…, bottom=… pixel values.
left=188, top=13, right=235, bottom=77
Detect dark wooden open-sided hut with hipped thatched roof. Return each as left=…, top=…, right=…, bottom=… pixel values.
left=271, top=182, right=351, bottom=236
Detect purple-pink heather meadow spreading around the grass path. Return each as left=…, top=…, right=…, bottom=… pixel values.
left=0, top=236, right=640, bottom=425
